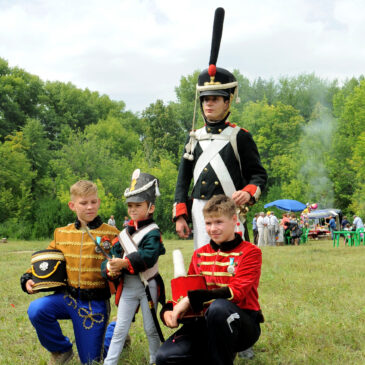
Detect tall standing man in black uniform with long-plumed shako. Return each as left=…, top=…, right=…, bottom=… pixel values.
left=173, top=8, right=267, bottom=249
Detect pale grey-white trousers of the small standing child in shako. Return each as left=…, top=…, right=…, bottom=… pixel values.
left=104, top=275, right=160, bottom=365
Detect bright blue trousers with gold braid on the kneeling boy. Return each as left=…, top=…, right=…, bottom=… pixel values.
left=28, top=293, right=109, bottom=364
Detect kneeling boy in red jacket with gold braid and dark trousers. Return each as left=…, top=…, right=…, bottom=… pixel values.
left=156, top=195, right=263, bottom=365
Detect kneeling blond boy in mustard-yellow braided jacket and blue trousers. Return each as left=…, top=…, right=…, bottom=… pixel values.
left=21, top=180, right=119, bottom=364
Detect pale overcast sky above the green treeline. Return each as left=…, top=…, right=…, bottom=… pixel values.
left=0, top=0, right=365, bottom=111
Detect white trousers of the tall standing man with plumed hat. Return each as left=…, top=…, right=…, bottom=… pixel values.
left=191, top=199, right=245, bottom=250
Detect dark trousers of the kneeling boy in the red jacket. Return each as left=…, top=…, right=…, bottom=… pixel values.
left=156, top=299, right=261, bottom=365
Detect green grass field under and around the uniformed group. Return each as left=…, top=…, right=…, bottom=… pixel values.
left=0, top=240, right=365, bottom=365
